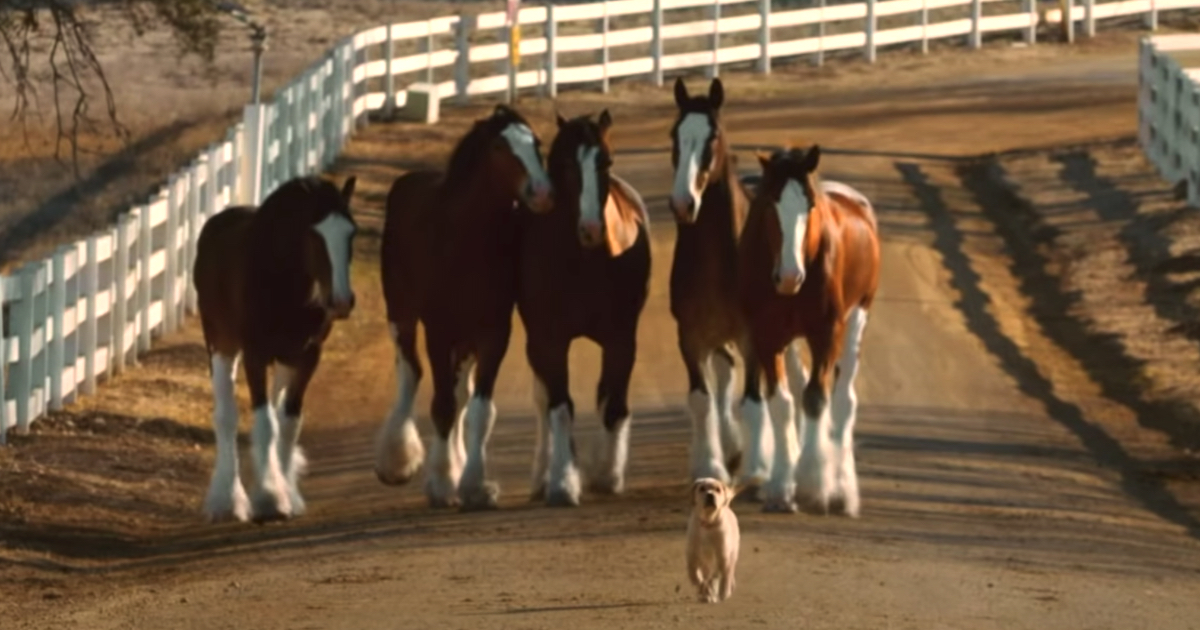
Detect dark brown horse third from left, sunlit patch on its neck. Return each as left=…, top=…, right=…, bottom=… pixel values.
left=517, top=109, right=650, bottom=505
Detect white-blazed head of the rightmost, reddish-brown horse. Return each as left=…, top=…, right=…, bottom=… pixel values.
left=754, top=144, right=821, bottom=295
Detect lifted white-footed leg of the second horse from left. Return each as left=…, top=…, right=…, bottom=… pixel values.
left=376, top=319, right=425, bottom=485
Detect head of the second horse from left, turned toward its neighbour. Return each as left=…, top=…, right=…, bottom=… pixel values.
left=463, top=104, right=553, bottom=214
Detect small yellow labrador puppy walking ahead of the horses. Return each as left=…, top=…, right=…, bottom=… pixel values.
left=688, top=478, right=742, bottom=604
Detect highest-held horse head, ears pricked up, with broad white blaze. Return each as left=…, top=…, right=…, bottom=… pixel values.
left=670, top=77, right=725, bottom=223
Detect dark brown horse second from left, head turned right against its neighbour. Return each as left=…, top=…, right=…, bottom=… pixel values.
left=376, top=104, right=552, bottom=509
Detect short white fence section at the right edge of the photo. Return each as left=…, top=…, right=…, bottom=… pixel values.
left=1138, top=34, right=1200, bottom=206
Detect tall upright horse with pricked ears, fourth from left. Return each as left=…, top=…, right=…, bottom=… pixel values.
left=670, top=78, right=804, bottom=499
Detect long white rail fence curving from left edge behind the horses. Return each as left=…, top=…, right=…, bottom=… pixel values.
left=0, top=0, right=1185, bottom=444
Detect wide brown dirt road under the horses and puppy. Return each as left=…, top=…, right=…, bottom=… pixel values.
left=0, top=38, right=1200, bottom=630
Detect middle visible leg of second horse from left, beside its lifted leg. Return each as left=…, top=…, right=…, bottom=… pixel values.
left=425, top=326, right=462, bottom=508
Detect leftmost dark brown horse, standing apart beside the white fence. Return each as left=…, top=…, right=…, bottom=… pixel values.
left=192, top=176, right=358, bottom=523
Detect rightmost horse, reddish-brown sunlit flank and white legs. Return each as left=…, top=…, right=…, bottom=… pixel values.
left=739, top=145, right=880, bottom=516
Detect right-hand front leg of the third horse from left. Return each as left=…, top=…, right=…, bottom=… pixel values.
left=590, top=330, right=637, bottom=494
